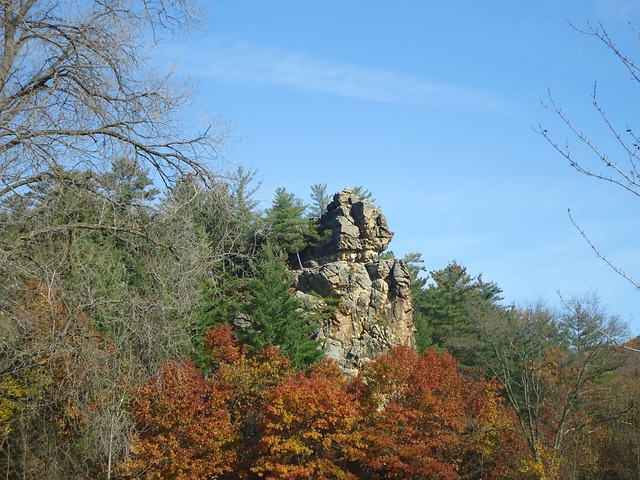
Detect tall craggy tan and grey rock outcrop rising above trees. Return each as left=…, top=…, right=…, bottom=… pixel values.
left=296, top=189, right=414, bottom=374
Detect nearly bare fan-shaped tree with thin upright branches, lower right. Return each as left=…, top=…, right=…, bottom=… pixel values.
left=480, top=297, right=625, bottom=479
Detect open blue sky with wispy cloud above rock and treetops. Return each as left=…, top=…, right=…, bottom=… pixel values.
left=162, top=0, right=640, bottom=334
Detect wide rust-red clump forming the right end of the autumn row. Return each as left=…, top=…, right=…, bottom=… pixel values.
left=355, top=347, right=508, bottom=479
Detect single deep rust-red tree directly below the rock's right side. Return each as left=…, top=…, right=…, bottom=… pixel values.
left=360, top=347, right=465, bottom=479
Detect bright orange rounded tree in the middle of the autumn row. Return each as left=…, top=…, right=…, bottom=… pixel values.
left=253, top=361, right=361, bottom=480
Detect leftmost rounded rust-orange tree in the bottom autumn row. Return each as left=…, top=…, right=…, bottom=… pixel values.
left=121, top=360, right=238, bottom=480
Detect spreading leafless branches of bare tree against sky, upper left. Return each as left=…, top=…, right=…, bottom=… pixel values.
left=0, top=0, right=225, bottom=199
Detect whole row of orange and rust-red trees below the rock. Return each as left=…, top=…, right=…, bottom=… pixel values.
left=121, top=327, right=515, bottom=480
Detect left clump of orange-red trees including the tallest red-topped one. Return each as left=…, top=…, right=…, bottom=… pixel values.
left=117, top=325, right=292, bottom=479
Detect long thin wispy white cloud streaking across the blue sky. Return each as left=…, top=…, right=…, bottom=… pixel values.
left=194, top=45, right=504, bottom=110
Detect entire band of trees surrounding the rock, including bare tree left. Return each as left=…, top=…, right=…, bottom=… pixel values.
left=0, top=0, right=640, bottom=480
